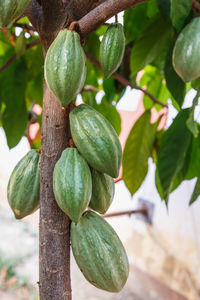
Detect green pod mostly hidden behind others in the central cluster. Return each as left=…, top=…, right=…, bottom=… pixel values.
left=89, top=169, right=115, bottom=214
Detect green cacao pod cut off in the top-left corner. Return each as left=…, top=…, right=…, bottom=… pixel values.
left=0, top=0, right=30, bottom=27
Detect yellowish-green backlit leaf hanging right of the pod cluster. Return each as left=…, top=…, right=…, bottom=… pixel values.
left=123, top=111, right=158, bottom=195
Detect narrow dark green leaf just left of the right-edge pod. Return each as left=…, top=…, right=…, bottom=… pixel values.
left=164, top=43, right=185, bottom=107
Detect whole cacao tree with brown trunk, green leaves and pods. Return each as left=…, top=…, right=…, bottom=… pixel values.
left=0, top=0, right=200, bottom=300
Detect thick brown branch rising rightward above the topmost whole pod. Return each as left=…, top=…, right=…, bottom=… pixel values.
left=78, top=0, right=149, bottom=37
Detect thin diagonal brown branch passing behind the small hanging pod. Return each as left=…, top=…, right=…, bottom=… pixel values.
left=85, top=51, right=168, bottom=107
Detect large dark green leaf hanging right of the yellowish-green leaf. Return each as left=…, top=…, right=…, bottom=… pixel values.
left=157, top=109, right=191, bottom=203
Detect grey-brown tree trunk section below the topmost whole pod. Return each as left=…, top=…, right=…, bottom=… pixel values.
left=39, top=87, right=71, bottom=300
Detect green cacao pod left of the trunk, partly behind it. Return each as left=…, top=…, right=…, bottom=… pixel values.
left=7, top=150, right=40, bottom=219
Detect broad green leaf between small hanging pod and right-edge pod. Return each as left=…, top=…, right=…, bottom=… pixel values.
left=131, top=17, right=171, bottom=73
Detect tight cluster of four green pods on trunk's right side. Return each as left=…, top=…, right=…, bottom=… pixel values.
left=53, top=104, right=129, bottom=292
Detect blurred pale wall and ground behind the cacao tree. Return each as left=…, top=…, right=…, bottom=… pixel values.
left=0, top=88, right=200, bottom=300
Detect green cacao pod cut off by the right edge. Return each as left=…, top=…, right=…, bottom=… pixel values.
left=172, top=17, right=200, bottom=82
